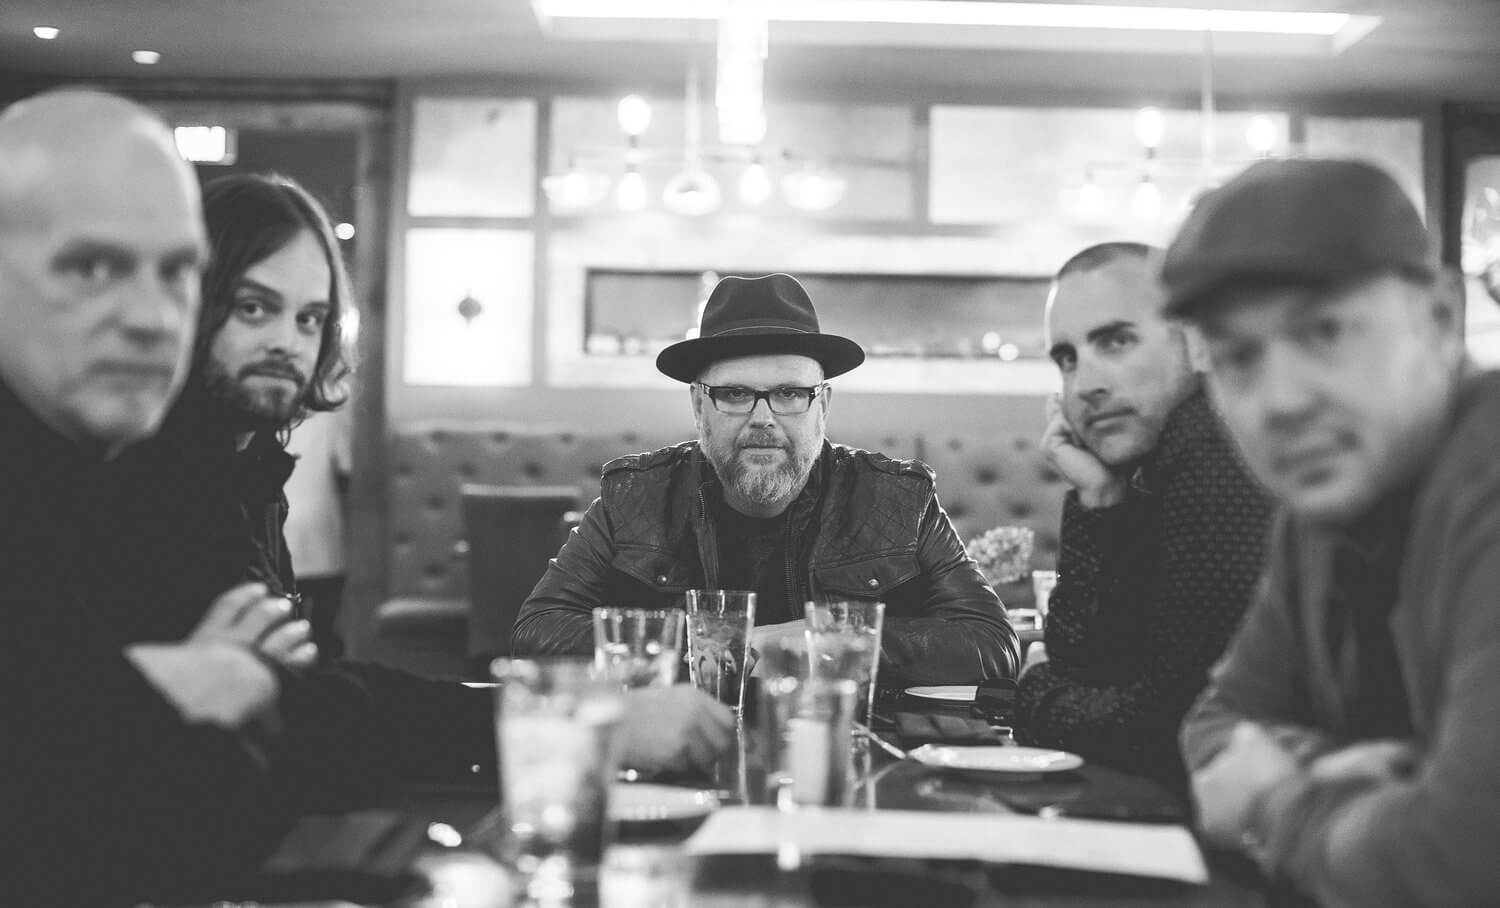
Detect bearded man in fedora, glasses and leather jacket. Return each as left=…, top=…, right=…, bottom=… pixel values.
left=512, top=275, right=1017, bottom=683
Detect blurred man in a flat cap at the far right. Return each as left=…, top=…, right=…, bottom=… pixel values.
left=1163, top=161, right=1500, bottom=908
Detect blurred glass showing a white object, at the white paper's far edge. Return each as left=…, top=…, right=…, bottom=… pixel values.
left=756, top=638, right=860, bottom=809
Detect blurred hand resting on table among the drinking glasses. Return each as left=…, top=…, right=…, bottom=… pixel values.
left=620, top=684, right=735, bottom=771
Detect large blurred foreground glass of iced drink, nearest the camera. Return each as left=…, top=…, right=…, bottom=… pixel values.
left=491, top=659, right=623, bottom=903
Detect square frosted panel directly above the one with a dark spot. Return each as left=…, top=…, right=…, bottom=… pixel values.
left=407, top=98, right=537, bottom=218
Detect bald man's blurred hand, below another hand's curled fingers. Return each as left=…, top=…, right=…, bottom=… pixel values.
left=125, top=641, right=278, bottom=729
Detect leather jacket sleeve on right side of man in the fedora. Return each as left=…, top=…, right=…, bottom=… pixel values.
left=882, top=497, right=1020, bottom=684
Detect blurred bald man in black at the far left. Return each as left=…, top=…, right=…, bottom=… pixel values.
left=0, top=92, right=304, bottom=905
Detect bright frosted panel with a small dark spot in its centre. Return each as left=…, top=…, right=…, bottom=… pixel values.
left=405, top=230, right=534, bottom=386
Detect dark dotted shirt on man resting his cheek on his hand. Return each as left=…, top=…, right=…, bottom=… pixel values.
left=1016, top=390, right=1272, bottom=785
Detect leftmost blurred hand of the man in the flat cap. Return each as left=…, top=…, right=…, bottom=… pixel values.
left=1193, top=722, right=1301, bottom=848
